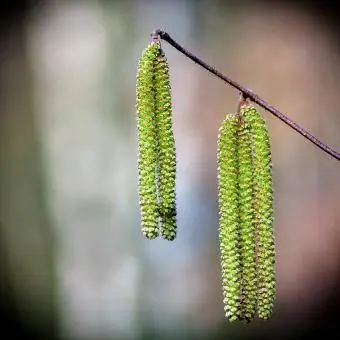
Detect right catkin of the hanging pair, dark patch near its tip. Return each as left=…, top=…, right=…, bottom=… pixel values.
left=155, top=54, right=177, bottom=241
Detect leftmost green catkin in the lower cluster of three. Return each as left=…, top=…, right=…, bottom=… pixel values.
left=217, top=114, right=243, bottom=321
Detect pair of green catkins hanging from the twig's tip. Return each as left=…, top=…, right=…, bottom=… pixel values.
left=136, top=41, right=177, bottom=241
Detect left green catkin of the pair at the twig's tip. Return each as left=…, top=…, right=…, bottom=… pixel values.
left=136, top=43, right=159, bottom=239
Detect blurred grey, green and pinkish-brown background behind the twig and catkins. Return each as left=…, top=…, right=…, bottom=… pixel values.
left=0, top=0, right=340, bottom=340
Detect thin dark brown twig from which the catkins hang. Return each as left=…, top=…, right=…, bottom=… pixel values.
left=152, top=29, right=340, bottom=161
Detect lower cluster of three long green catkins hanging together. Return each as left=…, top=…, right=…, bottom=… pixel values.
left=217, top=104, right=276, bottom=321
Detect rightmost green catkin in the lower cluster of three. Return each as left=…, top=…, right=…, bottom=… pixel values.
left=241, top=105, right=276, bottom=319
